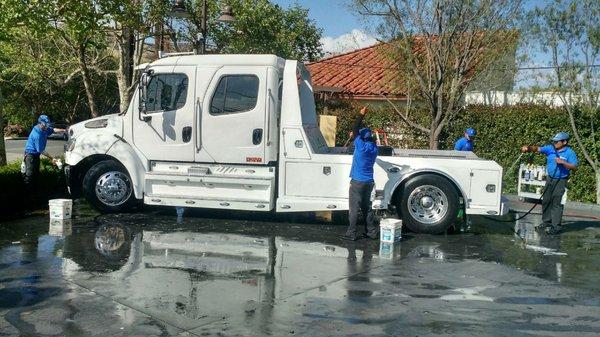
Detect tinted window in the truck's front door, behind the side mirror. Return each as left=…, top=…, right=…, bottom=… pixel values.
left=146, top=74, right=188, bottom=112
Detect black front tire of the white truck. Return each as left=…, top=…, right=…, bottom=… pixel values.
left=83, top=160, right=137, bottom=213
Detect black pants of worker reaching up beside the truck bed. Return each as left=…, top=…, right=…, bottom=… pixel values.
left=346, top=180, right=378, bottom=237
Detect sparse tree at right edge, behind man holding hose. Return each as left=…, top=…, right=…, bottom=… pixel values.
left=525, top=0, right=600, bottom=204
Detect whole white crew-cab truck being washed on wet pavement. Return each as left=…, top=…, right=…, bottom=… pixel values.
left=65, top=55, right=507, bottom=233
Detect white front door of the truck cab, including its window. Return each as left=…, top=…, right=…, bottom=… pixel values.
left=133, top=66, right=196, bottom=162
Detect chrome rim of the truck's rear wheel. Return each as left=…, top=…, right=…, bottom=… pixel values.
left=408, top=185, right=448, bottom=225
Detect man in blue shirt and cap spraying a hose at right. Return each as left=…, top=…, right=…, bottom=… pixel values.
left=521, top=132, right=579, bottom=234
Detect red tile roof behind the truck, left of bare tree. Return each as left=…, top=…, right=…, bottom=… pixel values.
left=306, top=44, right=405, bottom=99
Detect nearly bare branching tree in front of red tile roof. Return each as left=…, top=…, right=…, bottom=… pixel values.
left=354, top=0, right=520, bottom=149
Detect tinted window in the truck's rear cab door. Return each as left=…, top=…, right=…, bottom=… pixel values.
left=210, top=75, right=259, bottom=115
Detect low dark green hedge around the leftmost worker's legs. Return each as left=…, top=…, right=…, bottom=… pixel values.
left=0, top=159, right=67, bottom=219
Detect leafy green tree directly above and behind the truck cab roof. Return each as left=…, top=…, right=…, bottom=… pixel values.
left=168, top=0, right=322, bottom=61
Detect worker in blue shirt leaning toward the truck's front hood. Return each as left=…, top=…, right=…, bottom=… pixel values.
left=23, top=115, right=64, bottom=195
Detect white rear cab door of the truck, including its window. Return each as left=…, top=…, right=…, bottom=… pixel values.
left=196, top=66, right=267, bottom=165
